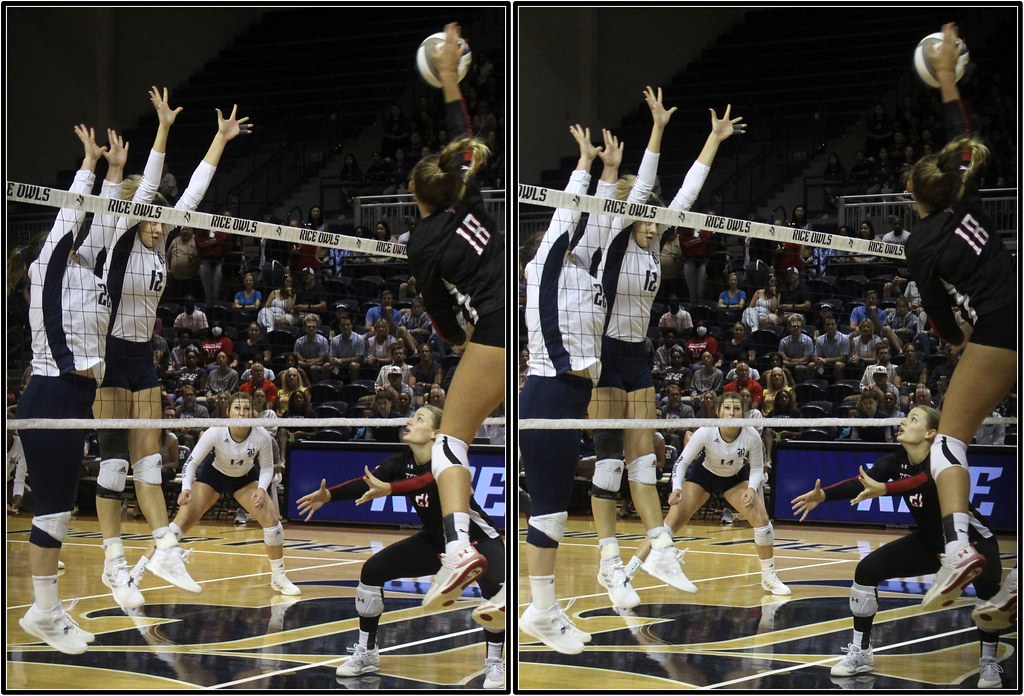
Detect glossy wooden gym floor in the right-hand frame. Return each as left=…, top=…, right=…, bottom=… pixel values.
left=517, top=515, right=1019, bottom=692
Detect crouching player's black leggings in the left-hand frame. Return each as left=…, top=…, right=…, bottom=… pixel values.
left=359, top=531, right=505, bottom=599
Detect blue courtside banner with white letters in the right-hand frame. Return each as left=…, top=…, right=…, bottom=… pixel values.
left=772, top=442, right=1018, bottom=531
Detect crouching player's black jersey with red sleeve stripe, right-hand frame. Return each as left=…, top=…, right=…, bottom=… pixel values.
left=822, top=447, right=992, bottom=540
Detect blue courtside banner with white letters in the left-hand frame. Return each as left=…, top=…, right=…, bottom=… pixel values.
left=285, top=442, right=505, bottom=529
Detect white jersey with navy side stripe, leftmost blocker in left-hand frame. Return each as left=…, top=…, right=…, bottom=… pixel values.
left=29, top=170, right=111, bottom=381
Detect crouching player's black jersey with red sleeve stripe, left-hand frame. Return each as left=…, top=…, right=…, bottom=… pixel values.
left=330, top=449, right=499, bottom=546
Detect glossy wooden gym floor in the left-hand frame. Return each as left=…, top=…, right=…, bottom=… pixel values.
left=4, top=512, right=505, bottom=692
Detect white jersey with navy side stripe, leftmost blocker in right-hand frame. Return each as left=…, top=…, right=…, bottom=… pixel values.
left=526, top=170, right=605, bottom=380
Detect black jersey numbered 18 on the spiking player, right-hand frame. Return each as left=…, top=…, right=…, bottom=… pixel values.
left=904, top=101, right=1017, bottom=343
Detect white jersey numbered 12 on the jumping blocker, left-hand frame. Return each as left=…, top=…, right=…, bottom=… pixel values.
left=95, top=153, right=216, bottom=343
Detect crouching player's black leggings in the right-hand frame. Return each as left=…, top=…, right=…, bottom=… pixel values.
left=853, top=531, right=1002, bottom=600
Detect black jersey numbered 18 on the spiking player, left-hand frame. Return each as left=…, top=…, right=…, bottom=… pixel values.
left=408, top=101, right=505, bottom=345
